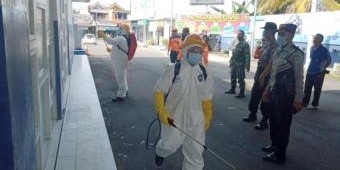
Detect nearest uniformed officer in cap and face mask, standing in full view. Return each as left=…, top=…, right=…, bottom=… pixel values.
left=262, top=24, right=304, bottom=163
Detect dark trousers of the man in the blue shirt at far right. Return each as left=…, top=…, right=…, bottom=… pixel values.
left=302, top=73, right=325, bottom=107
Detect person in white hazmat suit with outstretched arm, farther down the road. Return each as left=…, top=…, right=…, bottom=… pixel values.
left=98, top=24, right=130, bottom=102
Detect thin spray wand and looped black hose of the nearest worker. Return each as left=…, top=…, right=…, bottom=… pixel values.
left=145, top=118, right=237, bottom=170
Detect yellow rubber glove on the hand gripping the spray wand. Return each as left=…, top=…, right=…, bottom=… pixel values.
left=153, top=91, right=173, bottom=125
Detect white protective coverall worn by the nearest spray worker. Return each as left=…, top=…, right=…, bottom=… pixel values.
left=154, top=54, right=214, bottom=170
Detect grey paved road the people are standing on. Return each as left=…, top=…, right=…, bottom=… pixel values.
left=89, top=42, right=340, bottom=170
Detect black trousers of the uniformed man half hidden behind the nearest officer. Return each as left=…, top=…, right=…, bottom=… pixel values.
left=248, top=68, right=269, bottom=124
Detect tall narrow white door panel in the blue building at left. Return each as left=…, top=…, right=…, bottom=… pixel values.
left=31, top=7, right=52, bottom=170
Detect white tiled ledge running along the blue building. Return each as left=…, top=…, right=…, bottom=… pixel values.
left=56, top=55, right=117, bottom=170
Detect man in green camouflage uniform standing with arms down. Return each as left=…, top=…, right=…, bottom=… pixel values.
left=224, top=30, right=250, bottom=98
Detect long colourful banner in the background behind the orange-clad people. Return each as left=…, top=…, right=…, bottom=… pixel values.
left=175, top=14, right=249, bottom=34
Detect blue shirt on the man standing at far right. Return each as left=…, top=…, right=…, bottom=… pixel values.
left=307, top=45, right=331, bottom=75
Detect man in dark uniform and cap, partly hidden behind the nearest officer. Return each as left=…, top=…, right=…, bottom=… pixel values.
left=243, top=22, right=279, bottom=130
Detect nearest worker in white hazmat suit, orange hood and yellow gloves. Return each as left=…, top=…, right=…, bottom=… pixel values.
left=154, top=34, right=214, bottom=170
